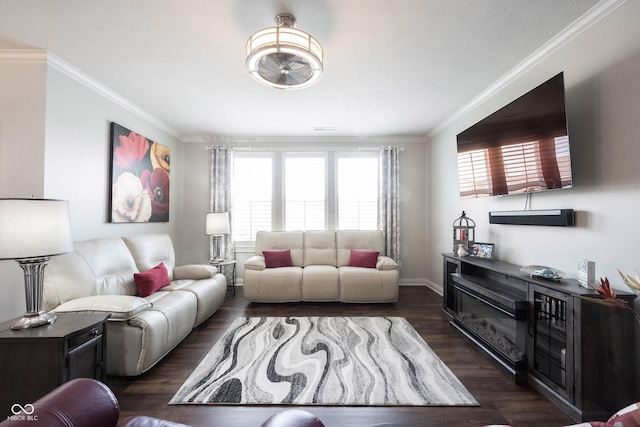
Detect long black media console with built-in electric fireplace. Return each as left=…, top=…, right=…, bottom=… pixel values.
left=442, top=254, right=640, bottom=421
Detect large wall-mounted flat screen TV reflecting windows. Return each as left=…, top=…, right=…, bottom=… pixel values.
left=457, top=73, right=573, bottom=198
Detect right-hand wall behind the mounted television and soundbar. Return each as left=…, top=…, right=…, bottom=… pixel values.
left=426, top=1, right=640, bottom=290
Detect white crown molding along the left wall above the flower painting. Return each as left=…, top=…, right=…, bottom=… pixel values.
left=0, top=49, right=184, bottom=141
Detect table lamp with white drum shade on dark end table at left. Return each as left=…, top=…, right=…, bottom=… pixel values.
left=0, top=199, right=73, bottom=329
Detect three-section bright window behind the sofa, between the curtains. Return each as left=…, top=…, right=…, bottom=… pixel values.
left=232, top=151, right=378, bottom=242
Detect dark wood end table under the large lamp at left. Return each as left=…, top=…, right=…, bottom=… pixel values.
left=0, top=313, right=110, bottom=419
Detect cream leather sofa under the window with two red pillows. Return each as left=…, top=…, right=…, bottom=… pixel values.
left=243, top=230, right=399, bottom=303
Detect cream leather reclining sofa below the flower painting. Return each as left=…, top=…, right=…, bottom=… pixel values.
left=43, top=234, right=227, bottom=376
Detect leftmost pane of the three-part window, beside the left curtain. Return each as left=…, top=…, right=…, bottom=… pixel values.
left=232, top=153, right=273, bottom=241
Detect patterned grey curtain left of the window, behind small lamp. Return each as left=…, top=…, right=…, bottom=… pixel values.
left=209, top=146, right=234, bottom=259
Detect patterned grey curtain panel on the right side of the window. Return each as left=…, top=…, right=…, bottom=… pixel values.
left=378, top=147, right=401, bottom=261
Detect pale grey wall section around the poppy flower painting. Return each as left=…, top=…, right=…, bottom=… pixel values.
left=45, top=67, right=182, bottom=240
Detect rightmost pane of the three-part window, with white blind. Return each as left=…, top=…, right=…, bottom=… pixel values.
left=337, top=155, right=378, bottom=230
